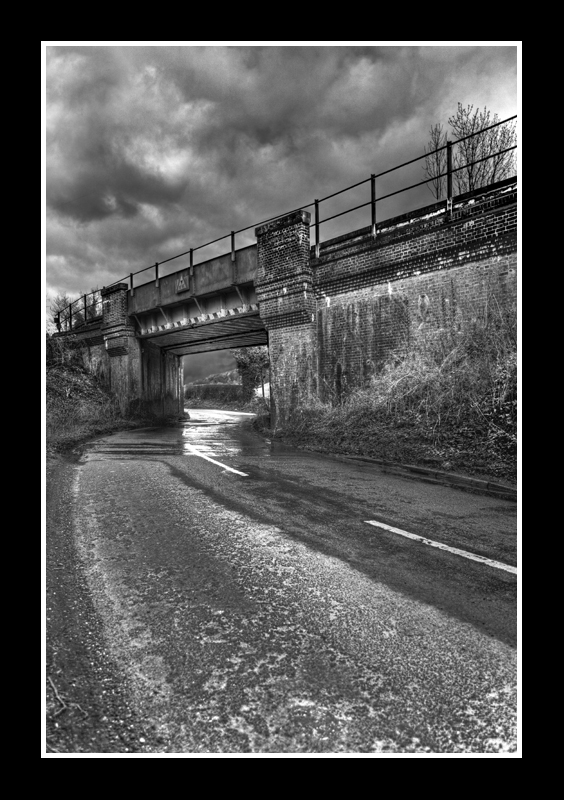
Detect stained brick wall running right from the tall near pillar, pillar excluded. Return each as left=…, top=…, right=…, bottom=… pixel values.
left=311, top=181, right=517, bottom=401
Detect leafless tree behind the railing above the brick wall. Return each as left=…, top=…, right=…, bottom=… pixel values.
left=423, top=103, right=517, bottom=198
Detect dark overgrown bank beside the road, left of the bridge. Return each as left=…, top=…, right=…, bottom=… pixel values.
left=45, top=337, right=163, bottom=453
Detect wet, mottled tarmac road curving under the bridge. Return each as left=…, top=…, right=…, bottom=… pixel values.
left=64, top=409, right=516, bottom=753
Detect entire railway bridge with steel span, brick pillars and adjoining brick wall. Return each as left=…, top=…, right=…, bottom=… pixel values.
left=60, top=178, right=517, bottom=424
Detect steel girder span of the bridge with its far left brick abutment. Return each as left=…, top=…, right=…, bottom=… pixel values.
left=64, top=245, right=268, bottom=416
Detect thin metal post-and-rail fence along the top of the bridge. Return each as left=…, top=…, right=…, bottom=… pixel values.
left=54, top=114, right=517, bottom=332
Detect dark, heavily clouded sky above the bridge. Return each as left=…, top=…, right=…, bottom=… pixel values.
left=45, top=42, right=518, bottom=378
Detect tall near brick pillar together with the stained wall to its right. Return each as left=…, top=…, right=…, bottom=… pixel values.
left=255, top=179, right=517, bottom=421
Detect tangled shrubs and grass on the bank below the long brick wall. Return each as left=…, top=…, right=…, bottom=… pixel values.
left=268, top=311, right=517, bottom=482
